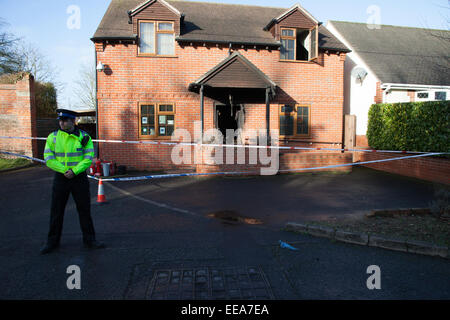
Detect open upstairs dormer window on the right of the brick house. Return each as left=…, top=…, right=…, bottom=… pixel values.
left=280, top=27, right=318, bottom=61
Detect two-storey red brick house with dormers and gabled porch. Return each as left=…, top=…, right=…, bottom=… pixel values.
left=91, top=0, right=351, bottom=170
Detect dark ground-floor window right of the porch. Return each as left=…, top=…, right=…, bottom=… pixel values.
left=280, top=105, right=310, bottom=137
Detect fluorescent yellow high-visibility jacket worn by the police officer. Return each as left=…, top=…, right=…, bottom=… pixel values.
left=44, top=128, right=94, bottom=175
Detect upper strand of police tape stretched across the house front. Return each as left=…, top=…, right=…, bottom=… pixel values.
left=0, top=136, right=449, bottom=154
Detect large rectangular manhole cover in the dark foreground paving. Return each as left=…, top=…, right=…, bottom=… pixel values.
left=146, top=267, right=275, bottom=300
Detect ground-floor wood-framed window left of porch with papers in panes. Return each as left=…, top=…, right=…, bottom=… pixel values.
left=139, top=103, right=175, bottom=138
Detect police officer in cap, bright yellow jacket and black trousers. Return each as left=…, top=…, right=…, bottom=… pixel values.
left=41, top=109, right=105, bottom=254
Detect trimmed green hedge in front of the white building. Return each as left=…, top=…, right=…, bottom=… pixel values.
left=367, top=101, right=450, bottom=152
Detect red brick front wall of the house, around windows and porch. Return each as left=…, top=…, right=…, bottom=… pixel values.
left=96, top=38, right=345, bottom=169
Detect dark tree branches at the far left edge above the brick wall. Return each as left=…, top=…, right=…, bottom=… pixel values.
left=0, top=18, right=20, bottom=75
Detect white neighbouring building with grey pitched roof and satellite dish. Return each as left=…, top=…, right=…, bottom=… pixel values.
left=327, top=21, right=450, bottom=146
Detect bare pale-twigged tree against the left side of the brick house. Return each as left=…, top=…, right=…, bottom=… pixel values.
left=74, top=63, right=96, bottom=109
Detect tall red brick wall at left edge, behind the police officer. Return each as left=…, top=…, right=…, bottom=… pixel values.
left=0, top=75, right=37, bottom=156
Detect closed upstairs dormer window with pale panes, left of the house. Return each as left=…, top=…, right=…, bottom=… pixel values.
left=139, top=21, right=175, bottom=56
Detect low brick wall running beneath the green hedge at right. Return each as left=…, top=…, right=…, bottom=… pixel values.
left=353, top=152, right=450, bottom=184
